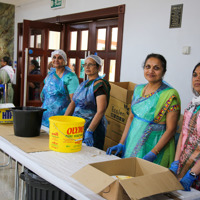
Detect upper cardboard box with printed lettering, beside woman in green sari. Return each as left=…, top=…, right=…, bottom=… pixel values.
left=105, top=82, right=136, bottom=125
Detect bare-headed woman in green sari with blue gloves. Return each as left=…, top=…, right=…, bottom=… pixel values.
left=107, top=54, right=180, bottom=167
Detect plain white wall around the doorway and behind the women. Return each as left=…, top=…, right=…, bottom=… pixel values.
left=15, top=0, right=200, bottom=113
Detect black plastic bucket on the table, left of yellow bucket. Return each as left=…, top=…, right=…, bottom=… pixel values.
left=11, top=106, right=46, bottom=137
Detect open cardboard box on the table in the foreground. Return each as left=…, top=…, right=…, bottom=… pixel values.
left=72, top=157, right=183, bottom=200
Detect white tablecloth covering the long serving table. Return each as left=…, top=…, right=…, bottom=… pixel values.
left=0, top=127, right=200, bottom=200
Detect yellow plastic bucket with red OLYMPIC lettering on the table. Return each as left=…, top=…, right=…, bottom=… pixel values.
left=49, top=116, right=85, bottom=153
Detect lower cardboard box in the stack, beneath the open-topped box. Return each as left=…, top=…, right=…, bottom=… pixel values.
left=106, top=117, right=125, bottom=144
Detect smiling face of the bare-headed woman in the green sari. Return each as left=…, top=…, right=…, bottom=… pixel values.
left=144, top=57, right=165, bottom=83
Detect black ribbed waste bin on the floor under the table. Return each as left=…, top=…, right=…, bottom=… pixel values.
left=20, top=169, right=75, bottom=200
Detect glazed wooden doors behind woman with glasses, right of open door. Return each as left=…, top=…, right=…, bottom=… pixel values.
left=66, top=18, right=120, bottom=81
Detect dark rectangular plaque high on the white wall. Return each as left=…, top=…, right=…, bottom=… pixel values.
left=169, top=4, right=183, bottom=28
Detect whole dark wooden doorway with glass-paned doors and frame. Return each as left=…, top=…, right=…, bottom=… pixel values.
left=14, top=5, right=125, bottom=106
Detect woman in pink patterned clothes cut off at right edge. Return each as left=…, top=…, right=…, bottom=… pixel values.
left=169, top=63, right=200, bottom=191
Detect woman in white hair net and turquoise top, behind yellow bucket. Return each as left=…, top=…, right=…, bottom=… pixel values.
left=40, top=50, right=79, bottom=127
